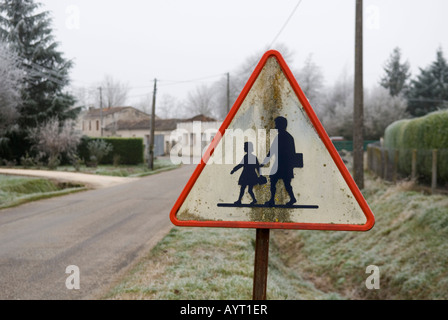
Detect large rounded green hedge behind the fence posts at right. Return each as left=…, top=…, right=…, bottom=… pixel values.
left=384, top=110, right=448, bottom=183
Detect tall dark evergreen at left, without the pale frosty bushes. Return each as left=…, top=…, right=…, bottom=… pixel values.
left=0, top=0, right=79, bottom=134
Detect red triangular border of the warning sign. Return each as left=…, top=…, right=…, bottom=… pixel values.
left=170, top=50, right=375, bottom=231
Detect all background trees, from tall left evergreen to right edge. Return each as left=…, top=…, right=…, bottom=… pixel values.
left=0, top=0, right=448, bottom=164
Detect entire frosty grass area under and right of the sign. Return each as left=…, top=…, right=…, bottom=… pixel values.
left=103, top=172, right=448, bottom=300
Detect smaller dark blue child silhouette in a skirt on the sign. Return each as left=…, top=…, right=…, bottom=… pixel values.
left=230, top=142, right=260, bottom=205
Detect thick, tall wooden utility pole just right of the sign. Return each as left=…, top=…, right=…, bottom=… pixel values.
left=353, top=0, right=364, bottom=189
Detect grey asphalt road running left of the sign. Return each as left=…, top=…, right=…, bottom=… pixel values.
left=0, top=166, right=194, bottom=300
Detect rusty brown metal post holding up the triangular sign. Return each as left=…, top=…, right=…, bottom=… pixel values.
left=252, top=229, right=269, bottom=300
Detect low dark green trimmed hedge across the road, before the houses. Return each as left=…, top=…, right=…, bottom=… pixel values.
left=78, top=137, right=145, bottom=165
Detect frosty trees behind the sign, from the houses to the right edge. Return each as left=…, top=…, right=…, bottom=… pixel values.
left=148, top=45, right=448, bottom=140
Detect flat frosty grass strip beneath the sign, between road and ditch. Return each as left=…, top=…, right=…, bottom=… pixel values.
left=103, top=227, right=339, bottom=300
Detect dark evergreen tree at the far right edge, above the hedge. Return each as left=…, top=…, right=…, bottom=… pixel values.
left=408, top=48, right=448, bottom=116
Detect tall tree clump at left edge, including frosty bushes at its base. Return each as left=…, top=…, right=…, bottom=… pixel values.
left=0, top=0, right=80, bottom=162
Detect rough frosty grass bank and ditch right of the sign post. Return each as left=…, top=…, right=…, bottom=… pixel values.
left=276, top=174, right=448, bottom=300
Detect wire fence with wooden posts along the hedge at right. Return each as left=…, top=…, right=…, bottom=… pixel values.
left=367, top=143, right=448, bottom=193
